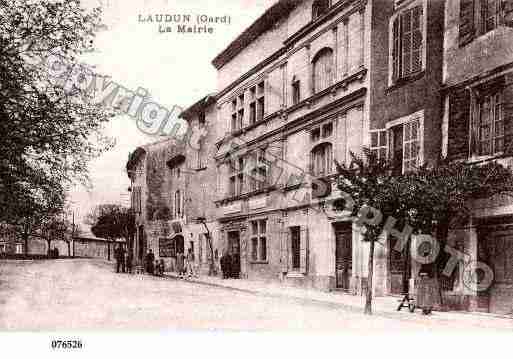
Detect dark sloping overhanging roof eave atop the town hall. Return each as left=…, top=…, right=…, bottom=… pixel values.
left=212, top=0, right=301, bottom=70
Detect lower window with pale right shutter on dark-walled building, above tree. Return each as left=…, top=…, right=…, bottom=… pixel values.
left=390, top=119, right=420, bottom=175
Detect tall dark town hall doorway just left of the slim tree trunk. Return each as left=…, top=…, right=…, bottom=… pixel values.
left=335, top=223, right=353, bottom=290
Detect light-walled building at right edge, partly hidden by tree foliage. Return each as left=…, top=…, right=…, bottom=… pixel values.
left=442, top=0, right=513, bottom=313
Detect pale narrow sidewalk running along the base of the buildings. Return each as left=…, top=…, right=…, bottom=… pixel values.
left=166, top=273, right=513, bottom=330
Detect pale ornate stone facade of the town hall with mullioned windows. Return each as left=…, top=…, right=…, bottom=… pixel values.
left=214, top=1, right=372, bottom=293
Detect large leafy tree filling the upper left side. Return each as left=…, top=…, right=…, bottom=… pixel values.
left=0, top=0, right=112, bottom=228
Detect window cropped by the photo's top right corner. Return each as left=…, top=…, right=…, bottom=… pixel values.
left=459, top=0, right=513, bottom=46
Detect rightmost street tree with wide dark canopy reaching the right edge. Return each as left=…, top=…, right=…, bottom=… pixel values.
left=403, top=159, right=513, bottom=305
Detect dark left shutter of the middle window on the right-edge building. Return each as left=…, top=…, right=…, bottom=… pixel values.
left=448, top=89, right=470, bottom=160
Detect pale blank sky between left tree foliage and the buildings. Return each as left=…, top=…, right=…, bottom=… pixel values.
left=70, top=0, right=276, bottom=226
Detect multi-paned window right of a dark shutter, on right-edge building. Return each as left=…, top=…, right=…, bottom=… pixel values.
left=477, top=93, right=504, bottom=156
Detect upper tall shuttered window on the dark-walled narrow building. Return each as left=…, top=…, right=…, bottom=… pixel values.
left=391, top=5, right=424, bottom=83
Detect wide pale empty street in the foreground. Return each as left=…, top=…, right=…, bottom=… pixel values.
left=0, top=259, right=510, bottom=331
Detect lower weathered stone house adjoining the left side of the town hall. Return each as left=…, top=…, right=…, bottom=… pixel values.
left=127, top=95, right=218, bottom=271
